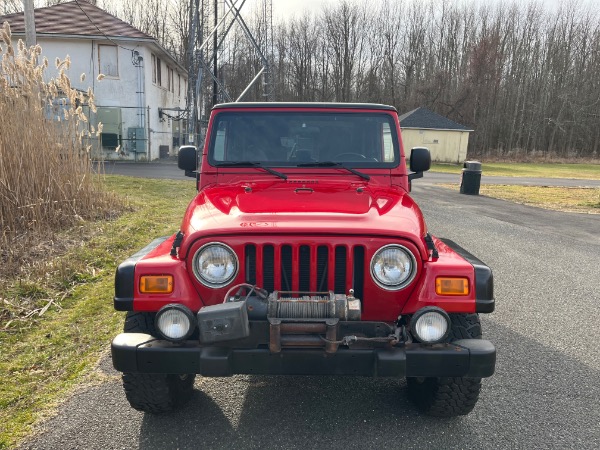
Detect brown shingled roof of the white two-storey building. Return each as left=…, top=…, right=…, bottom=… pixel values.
left=0, top=0, right=154, bottom=40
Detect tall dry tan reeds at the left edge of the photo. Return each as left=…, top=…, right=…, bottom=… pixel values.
left=0, top=23, right=120, bottom=278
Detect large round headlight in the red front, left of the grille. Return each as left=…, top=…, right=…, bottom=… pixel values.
left=192, top=243, right=238, bottom=288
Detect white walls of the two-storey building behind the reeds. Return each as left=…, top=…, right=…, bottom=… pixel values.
left=9, top=36, right=186, bottom=160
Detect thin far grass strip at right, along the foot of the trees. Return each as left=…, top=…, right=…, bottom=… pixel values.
left=431, top=163, right=600, bottom=180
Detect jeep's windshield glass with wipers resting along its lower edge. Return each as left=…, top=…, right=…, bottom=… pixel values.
left=208, top=111, right=400, bottom=168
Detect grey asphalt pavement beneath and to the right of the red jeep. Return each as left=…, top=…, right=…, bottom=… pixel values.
left=18, top=171, right=600, bottom=450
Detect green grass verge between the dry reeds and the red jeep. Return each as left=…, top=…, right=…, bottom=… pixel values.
left=0, top=176, right=195, bottom=448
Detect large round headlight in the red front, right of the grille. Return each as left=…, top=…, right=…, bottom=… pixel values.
left=371, top=244, right=417, bottom=290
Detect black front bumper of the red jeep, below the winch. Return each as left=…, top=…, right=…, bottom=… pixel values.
left=112, top=333, right=496, bottom=378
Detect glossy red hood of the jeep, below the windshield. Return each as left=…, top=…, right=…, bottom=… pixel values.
left=181, top=180, right=427, bottom=256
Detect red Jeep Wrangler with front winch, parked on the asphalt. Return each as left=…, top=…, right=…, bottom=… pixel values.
left=112, top=103, right=496, bottom=416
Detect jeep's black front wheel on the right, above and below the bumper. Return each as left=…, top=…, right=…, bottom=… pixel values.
left=406, top=314, right=481, bottom=417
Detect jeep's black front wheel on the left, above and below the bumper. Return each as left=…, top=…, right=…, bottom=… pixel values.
left=122, top=311, right=196, bottom=414
